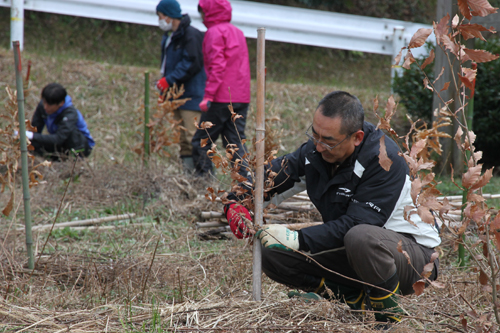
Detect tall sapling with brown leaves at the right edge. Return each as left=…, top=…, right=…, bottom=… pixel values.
left=390, top=0, right=500, bottom=331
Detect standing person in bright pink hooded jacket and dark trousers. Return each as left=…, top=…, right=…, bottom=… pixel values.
left=192, top=0, right=250, bottom=176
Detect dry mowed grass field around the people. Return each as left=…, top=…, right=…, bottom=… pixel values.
left=0, top=23, right=494, bottom=332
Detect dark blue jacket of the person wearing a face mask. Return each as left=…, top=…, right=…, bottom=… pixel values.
left=161, top=14, right=207, bottom=111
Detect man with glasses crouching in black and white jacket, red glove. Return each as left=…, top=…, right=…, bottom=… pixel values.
left=224, top=91, right=441, bottom=322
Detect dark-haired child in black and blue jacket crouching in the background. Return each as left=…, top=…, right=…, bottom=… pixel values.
left=26, top=83, right=95, bottom=160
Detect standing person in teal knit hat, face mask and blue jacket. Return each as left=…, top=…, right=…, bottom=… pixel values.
left=156, top=0, right=206, bottom=172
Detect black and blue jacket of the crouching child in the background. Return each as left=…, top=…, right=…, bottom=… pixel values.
left=31, top=102, right=93, bottom=156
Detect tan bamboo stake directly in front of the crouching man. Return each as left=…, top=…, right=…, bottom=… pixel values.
left=252, top=28, right=266, bottom=301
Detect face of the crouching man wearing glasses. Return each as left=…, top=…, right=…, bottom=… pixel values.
left=310, top=109, right=364, bottom=163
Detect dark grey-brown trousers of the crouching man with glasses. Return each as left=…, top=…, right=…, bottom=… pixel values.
left=262, top=224, right=439, bottom=295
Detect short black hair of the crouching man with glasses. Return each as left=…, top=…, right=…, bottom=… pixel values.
left=317, top=91, right=365, bottom=134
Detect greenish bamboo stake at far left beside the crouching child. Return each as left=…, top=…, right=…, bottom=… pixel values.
left=12, top=41, right=35, bottom=269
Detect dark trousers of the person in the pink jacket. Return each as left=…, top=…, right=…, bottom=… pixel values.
left=191, top=103, right=248, bottom=176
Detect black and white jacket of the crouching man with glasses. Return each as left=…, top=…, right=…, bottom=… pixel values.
left=230, top=122, right=441, bottom=253
